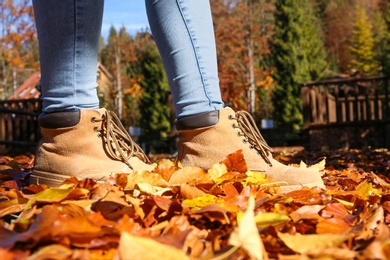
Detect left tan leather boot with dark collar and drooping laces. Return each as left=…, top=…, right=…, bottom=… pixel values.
left=30, top=109, right=153, bottom=186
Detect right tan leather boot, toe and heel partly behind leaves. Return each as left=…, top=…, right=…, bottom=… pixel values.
left=176, top=108, right=325, bottom=192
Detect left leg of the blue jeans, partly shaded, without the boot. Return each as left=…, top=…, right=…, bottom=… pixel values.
left=33, top=0, right=104, bottom=113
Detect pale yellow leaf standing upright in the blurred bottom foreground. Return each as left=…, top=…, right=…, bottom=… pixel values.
left=228, top=196, right=267, bottom=259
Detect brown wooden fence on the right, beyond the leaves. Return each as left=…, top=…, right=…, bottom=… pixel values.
left=301, top=76, right=390, bottom=148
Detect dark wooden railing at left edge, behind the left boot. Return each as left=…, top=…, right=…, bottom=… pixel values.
left=0, top=99, right=41, bottom=152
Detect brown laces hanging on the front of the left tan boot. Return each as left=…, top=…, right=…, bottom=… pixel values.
left=91, top=111, right=150, bottom=169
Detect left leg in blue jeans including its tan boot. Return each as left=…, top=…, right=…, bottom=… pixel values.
left=30, top=0, right=153, bottom=186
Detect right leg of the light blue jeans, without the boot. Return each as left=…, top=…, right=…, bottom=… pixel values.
left=146, top=0, right=224, bottom=118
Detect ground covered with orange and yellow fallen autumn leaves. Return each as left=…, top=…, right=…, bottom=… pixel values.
left=0, top=149, right=390, bottom=260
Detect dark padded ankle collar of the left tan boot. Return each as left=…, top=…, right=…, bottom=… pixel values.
left=38, top=110, right=80, bottom=128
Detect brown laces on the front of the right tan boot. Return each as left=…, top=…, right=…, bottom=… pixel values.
left=230, top=111, right=272, bottom=166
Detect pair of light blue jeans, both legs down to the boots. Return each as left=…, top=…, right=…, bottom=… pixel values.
left=33, top=0, right=223, bottom=118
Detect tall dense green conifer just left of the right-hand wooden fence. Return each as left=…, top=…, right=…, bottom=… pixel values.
left=272, top=0, right=327, bottom=129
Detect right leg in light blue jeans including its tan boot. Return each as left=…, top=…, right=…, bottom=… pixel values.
left=146, top=0, right=324, bottom=191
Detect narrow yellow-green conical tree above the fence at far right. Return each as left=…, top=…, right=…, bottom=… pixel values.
left=349, top=6, right=379, bottom=76
